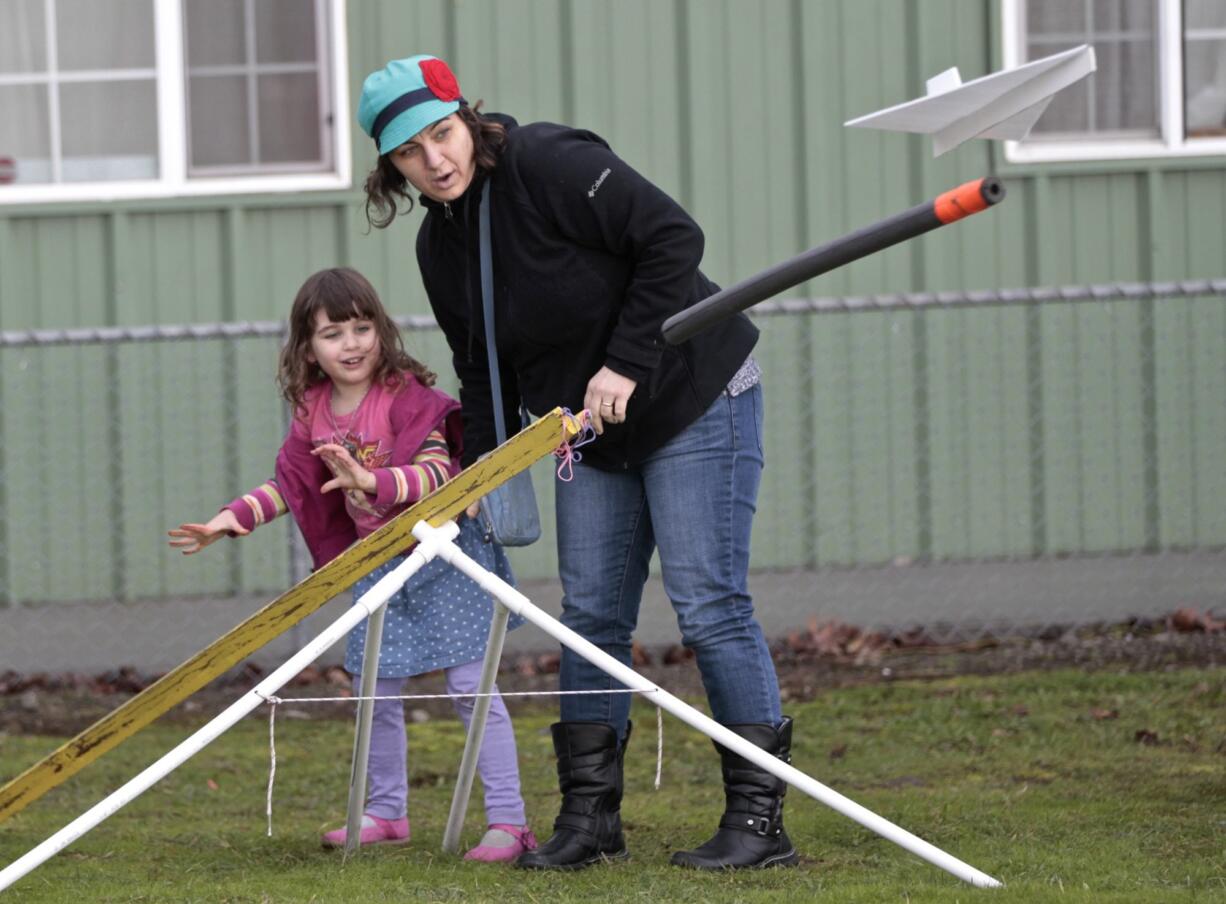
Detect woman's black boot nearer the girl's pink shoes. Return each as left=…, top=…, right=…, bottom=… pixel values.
left=515, top=722, right=630, bottom=870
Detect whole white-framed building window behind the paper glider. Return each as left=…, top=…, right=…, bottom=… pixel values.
left=1002, top=0, right=1226, bottom=162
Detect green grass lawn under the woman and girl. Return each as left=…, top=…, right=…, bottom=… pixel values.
left=0, top=668, right=1226, bottom=904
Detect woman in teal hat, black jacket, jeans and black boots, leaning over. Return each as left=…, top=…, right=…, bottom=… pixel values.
left=358, top=55, right=797, bottom=870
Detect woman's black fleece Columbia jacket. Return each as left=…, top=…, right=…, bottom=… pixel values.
left=417, top=114, right=758, bottom=470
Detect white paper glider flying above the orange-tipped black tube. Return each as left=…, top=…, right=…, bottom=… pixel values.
left=843, top=44, right=1095, bottom=157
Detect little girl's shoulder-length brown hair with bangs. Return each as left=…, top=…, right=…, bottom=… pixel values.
left=277, top=267, right=435, bottom=416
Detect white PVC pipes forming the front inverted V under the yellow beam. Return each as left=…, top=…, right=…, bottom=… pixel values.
left=0, top=521, right=1002, bottom=891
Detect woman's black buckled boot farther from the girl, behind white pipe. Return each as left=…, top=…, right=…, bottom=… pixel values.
left=672, top=716, right=799, bottom=870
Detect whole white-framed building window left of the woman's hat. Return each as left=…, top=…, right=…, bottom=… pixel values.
left=0, top=0, right=348, bottom=204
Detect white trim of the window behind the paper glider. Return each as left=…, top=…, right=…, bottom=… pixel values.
left=1000, top=0, right=1226, bottom=163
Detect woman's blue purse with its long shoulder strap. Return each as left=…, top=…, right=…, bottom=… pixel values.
left=478, top=179, right=541, bottom=546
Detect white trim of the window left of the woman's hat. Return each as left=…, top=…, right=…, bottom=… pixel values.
left=0, top=0, right=352, bottom=206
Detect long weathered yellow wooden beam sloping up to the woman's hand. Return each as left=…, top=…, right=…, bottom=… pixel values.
left=0, top=408, right=579, bottom=822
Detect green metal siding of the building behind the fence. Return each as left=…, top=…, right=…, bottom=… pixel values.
left=0, top=0, right=1226, bottom=600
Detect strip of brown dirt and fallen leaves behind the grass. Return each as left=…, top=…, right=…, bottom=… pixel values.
left=0, top=611, right=1226, bottom=737
